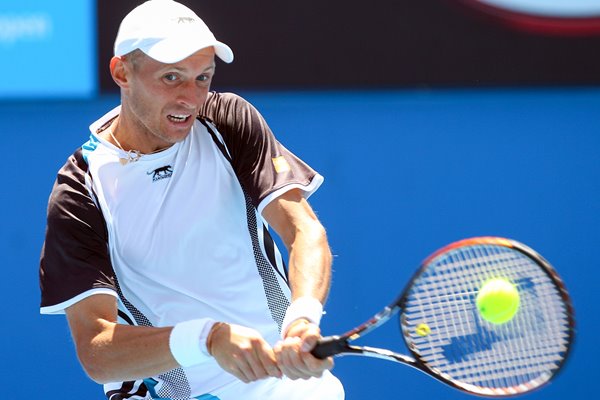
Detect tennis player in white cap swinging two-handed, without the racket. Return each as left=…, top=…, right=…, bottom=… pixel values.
left=40, top=0, right=344, bottom=400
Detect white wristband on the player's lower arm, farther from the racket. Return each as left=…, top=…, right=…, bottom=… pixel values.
left=169, top=318, right=215, bottom=367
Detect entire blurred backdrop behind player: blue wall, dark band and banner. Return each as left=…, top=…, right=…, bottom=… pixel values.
left=0, top=0, right=600, bottom=400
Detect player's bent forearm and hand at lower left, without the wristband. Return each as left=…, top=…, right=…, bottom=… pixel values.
left=66, top=294, right=281, bottom=383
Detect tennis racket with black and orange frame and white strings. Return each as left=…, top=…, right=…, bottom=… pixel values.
left=312, top=237, right=574, bottom=397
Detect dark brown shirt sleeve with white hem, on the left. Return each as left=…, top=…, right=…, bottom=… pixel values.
left=40, top=150, right=116, bottom=314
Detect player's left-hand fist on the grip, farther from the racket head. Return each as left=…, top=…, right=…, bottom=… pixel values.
left=206, top=322, right=281, bottom=383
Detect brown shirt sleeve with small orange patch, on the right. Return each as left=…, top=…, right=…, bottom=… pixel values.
left=200, top=92, right=323, bottom=211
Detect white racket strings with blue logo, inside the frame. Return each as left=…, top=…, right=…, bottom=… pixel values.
left=402, top=245, right=570, bottom=392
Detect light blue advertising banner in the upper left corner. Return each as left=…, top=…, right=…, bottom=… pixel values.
left=0, top=0, right=97, bottom=98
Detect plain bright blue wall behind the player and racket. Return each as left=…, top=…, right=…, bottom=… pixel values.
left=0, top=89, right=600, bottom=400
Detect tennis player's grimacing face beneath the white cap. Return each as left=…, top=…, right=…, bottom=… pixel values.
left=123, top=47, right=215, bottom=148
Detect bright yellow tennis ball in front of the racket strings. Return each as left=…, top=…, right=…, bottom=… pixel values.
left=475, top=278, right=520, bottom=324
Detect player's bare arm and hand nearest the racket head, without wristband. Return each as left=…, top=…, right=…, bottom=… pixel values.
left=263, top=189, right=333, bottom=379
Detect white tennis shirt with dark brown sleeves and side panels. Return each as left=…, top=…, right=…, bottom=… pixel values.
left=40, top=93, right=342, bottom=399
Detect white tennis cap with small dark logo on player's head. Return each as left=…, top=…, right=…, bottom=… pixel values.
left=115, top=0, right=233, bottom=64
